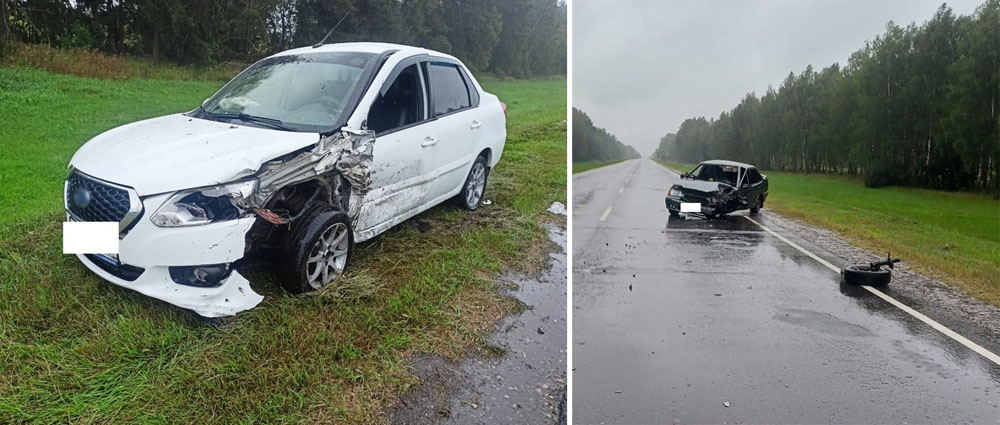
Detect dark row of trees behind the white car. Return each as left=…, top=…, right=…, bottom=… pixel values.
left=0, top=0, right=566, bottom=77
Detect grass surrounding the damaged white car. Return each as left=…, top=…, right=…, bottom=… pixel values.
left=0, top=64, right=566, bottom=424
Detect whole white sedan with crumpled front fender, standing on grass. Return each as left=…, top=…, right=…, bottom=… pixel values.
left=65, top=43, right=507, bottom=317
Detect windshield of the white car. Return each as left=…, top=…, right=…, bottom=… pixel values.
left=199, top=52, right=375, bottom=132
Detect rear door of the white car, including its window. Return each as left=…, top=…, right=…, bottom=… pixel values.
left=424, top=59, right=483, bottom=204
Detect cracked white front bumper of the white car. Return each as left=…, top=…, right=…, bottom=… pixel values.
left=77, top=193, right=264, bottom=317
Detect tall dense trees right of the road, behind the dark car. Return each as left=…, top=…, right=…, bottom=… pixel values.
left=654, top=0, right=1000, bottom=194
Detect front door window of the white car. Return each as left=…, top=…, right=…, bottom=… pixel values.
left=368, top=64, right=424, bottom=135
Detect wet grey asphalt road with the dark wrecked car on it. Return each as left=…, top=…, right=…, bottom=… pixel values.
left=572, top=159, right=1000, bottom=424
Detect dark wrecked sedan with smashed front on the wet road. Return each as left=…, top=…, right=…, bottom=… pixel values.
left=666, top=160, right=767, bottom=217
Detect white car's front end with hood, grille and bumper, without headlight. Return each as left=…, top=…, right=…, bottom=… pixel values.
left=64, top=114, right=316, bottom=317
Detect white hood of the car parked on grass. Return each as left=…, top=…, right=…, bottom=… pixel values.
left=70, top=114, right=319, bottom=196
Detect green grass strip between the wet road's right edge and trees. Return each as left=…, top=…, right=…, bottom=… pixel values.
left=664, top=162, right=1000, bottom=306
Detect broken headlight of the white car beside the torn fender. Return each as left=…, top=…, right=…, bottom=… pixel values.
left=150, top=180, right=257, bottom=227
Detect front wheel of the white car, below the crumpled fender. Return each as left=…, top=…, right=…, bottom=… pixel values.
left=281, top=205, right=354, bottom=294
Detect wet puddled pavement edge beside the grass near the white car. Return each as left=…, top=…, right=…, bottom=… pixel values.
left=390, top=226, right=567, bottom=424
